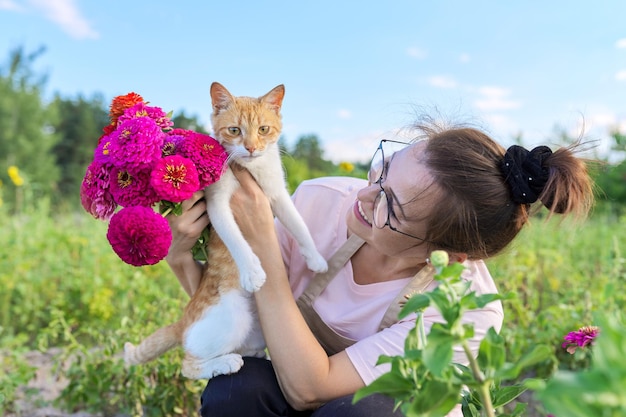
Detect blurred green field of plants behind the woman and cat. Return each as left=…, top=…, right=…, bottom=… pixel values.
left=0, top=192, right=626, bottom=416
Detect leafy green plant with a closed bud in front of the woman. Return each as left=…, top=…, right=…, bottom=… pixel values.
left=354, top=251, right=552, bottom=417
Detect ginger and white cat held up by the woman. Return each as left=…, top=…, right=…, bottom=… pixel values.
left=124, top=83, right=328, bottom=379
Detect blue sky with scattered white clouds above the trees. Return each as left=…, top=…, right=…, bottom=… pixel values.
left=0, top=0, right=626, bottom=162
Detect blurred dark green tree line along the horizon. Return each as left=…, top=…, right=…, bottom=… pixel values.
left=0, top=47, right=626, bottom=209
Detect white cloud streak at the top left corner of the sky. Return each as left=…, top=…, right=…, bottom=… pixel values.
left=30, top=0, right=100, bottom=39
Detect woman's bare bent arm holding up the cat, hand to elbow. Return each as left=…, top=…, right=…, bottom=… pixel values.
left=231, top=169, right=364, bottom=409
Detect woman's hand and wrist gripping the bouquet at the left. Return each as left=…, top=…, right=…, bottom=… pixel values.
left=165, top=191, right=209, bottom=297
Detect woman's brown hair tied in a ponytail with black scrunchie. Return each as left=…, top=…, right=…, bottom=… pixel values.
left=414, top=118, right=593, bottom=259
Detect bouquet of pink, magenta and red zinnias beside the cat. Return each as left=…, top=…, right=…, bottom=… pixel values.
left=80, top=93, right=227, bottom=266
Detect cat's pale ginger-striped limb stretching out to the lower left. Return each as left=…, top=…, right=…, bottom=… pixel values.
left=124, top=323, right=182, bottom=365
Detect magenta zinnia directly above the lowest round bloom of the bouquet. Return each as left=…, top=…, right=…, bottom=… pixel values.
left=110, top=164, right=160, bottom=207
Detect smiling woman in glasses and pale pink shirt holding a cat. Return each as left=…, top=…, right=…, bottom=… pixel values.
left=167, top=118, right=592, bottom=417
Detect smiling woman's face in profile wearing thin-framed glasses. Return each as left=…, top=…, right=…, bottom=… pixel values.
left=346, top=141, right=438, bottom=258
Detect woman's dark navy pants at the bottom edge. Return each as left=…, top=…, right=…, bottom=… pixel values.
left=200, top=358, right=402, bottom=417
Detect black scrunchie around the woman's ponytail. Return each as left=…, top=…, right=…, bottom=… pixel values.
left=500, top=145, right=552, bottom=204
